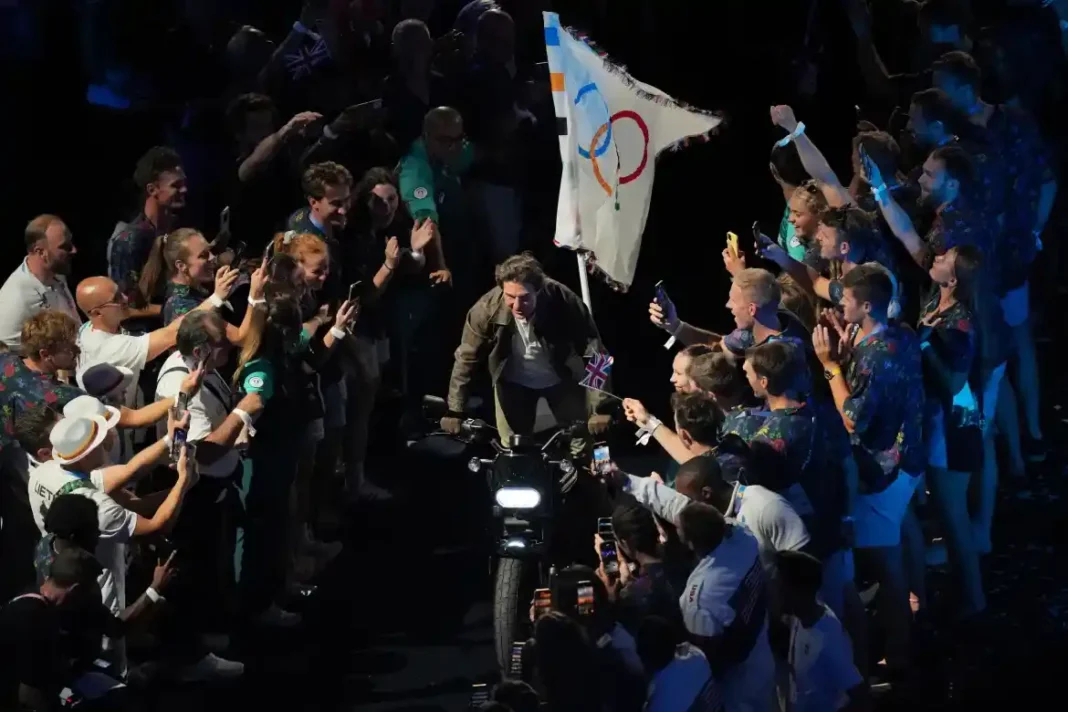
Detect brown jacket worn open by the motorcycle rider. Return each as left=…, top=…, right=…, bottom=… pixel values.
left=449, top=279, right=610, bottom=413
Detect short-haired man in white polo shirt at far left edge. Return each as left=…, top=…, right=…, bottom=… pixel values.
left=0, top=215, right=81, bottom=350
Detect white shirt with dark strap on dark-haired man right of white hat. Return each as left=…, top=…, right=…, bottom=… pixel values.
left=156, top=351, right=241, bottom=477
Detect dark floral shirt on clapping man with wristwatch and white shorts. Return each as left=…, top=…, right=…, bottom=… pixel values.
left=842, top=325, right=926, bottom=493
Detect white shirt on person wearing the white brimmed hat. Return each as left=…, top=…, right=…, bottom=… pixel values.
left=29, top=460, right=137, bottom=615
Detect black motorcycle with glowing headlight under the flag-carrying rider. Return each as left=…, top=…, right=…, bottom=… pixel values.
left=424, top=397, right=603, bottom=674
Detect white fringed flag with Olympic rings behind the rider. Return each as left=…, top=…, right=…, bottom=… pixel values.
left=544, top=13, right=722, bottom=289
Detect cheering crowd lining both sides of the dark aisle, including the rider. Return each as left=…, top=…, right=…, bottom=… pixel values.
left=0, top=0, right=1068, bottom=712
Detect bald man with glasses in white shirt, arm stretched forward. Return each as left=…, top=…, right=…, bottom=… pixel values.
left=75, top=276, right=213, bottom=408
